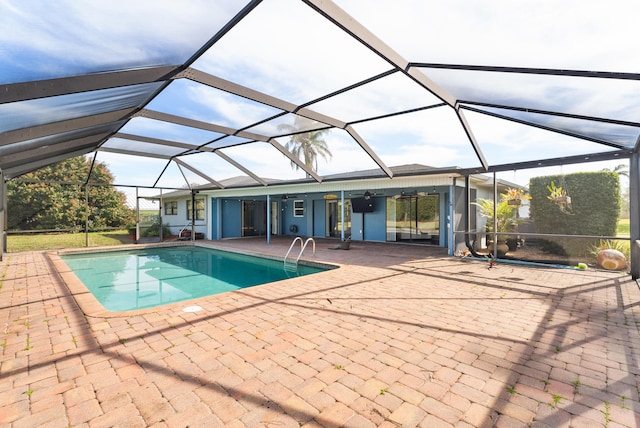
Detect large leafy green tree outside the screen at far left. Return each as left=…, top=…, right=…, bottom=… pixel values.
left=7, top=156, right=134, bottom=230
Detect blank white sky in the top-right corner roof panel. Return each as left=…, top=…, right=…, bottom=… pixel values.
left=336, top=0, right=640, bottom=72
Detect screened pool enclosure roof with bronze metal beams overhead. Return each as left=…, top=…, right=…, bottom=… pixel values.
left=0, top=0, right=640, bottom=188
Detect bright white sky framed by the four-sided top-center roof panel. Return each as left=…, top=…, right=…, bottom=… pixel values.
left=195, top=0, right=391, bottom=103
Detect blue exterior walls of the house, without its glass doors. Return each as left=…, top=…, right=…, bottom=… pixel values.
left=156, top=177, right=510, bottom=254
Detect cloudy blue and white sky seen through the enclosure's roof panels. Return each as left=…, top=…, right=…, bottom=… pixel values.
left=0, top=0, right=640, bottom=199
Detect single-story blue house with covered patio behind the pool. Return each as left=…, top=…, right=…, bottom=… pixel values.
left=152, top=165, right=524, bottom=254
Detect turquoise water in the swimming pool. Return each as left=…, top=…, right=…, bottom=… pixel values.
left=61, top=247, right=327, bottom=311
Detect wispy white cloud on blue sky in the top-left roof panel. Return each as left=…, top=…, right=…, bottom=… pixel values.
left=0, top=0, right=241, bottom=77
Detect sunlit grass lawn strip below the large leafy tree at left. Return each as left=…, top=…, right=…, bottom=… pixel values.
left=7, top=230, right=131, bottom=253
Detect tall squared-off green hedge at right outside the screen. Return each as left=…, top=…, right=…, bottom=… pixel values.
left=529, top=171, right=621, bottom=255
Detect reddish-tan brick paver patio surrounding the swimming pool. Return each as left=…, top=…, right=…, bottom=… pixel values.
left=0, top=240, right=640, bottom=427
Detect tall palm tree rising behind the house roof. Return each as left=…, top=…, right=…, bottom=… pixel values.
left=278, top=116, right=333, bottom=172
